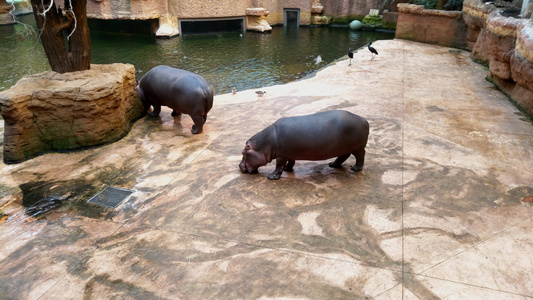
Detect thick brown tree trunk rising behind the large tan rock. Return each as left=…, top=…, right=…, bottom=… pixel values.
left=31, top=0, right=91, bottom=73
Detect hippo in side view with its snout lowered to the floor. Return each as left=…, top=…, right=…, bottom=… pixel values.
left=239, top=110, right=369, bottom=179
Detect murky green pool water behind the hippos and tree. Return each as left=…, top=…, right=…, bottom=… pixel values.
left=0, top=15, right=394, bottom=94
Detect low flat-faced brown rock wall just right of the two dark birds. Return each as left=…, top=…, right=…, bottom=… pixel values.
left=396, top=3, right=466, bottom=48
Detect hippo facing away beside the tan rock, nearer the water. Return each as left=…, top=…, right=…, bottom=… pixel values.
left=136, top=66, right=213, bottom=134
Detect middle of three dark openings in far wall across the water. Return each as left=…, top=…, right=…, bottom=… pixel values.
left=179, top=18, right=246, bottom=34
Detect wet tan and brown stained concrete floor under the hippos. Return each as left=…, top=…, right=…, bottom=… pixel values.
left=0, top=40, right=533, bottom=299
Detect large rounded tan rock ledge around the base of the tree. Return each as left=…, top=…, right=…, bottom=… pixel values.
left=0, top=64, right=144, bottom=163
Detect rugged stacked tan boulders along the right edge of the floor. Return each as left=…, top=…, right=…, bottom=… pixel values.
left=463, top=0, right=533, bottom=116
